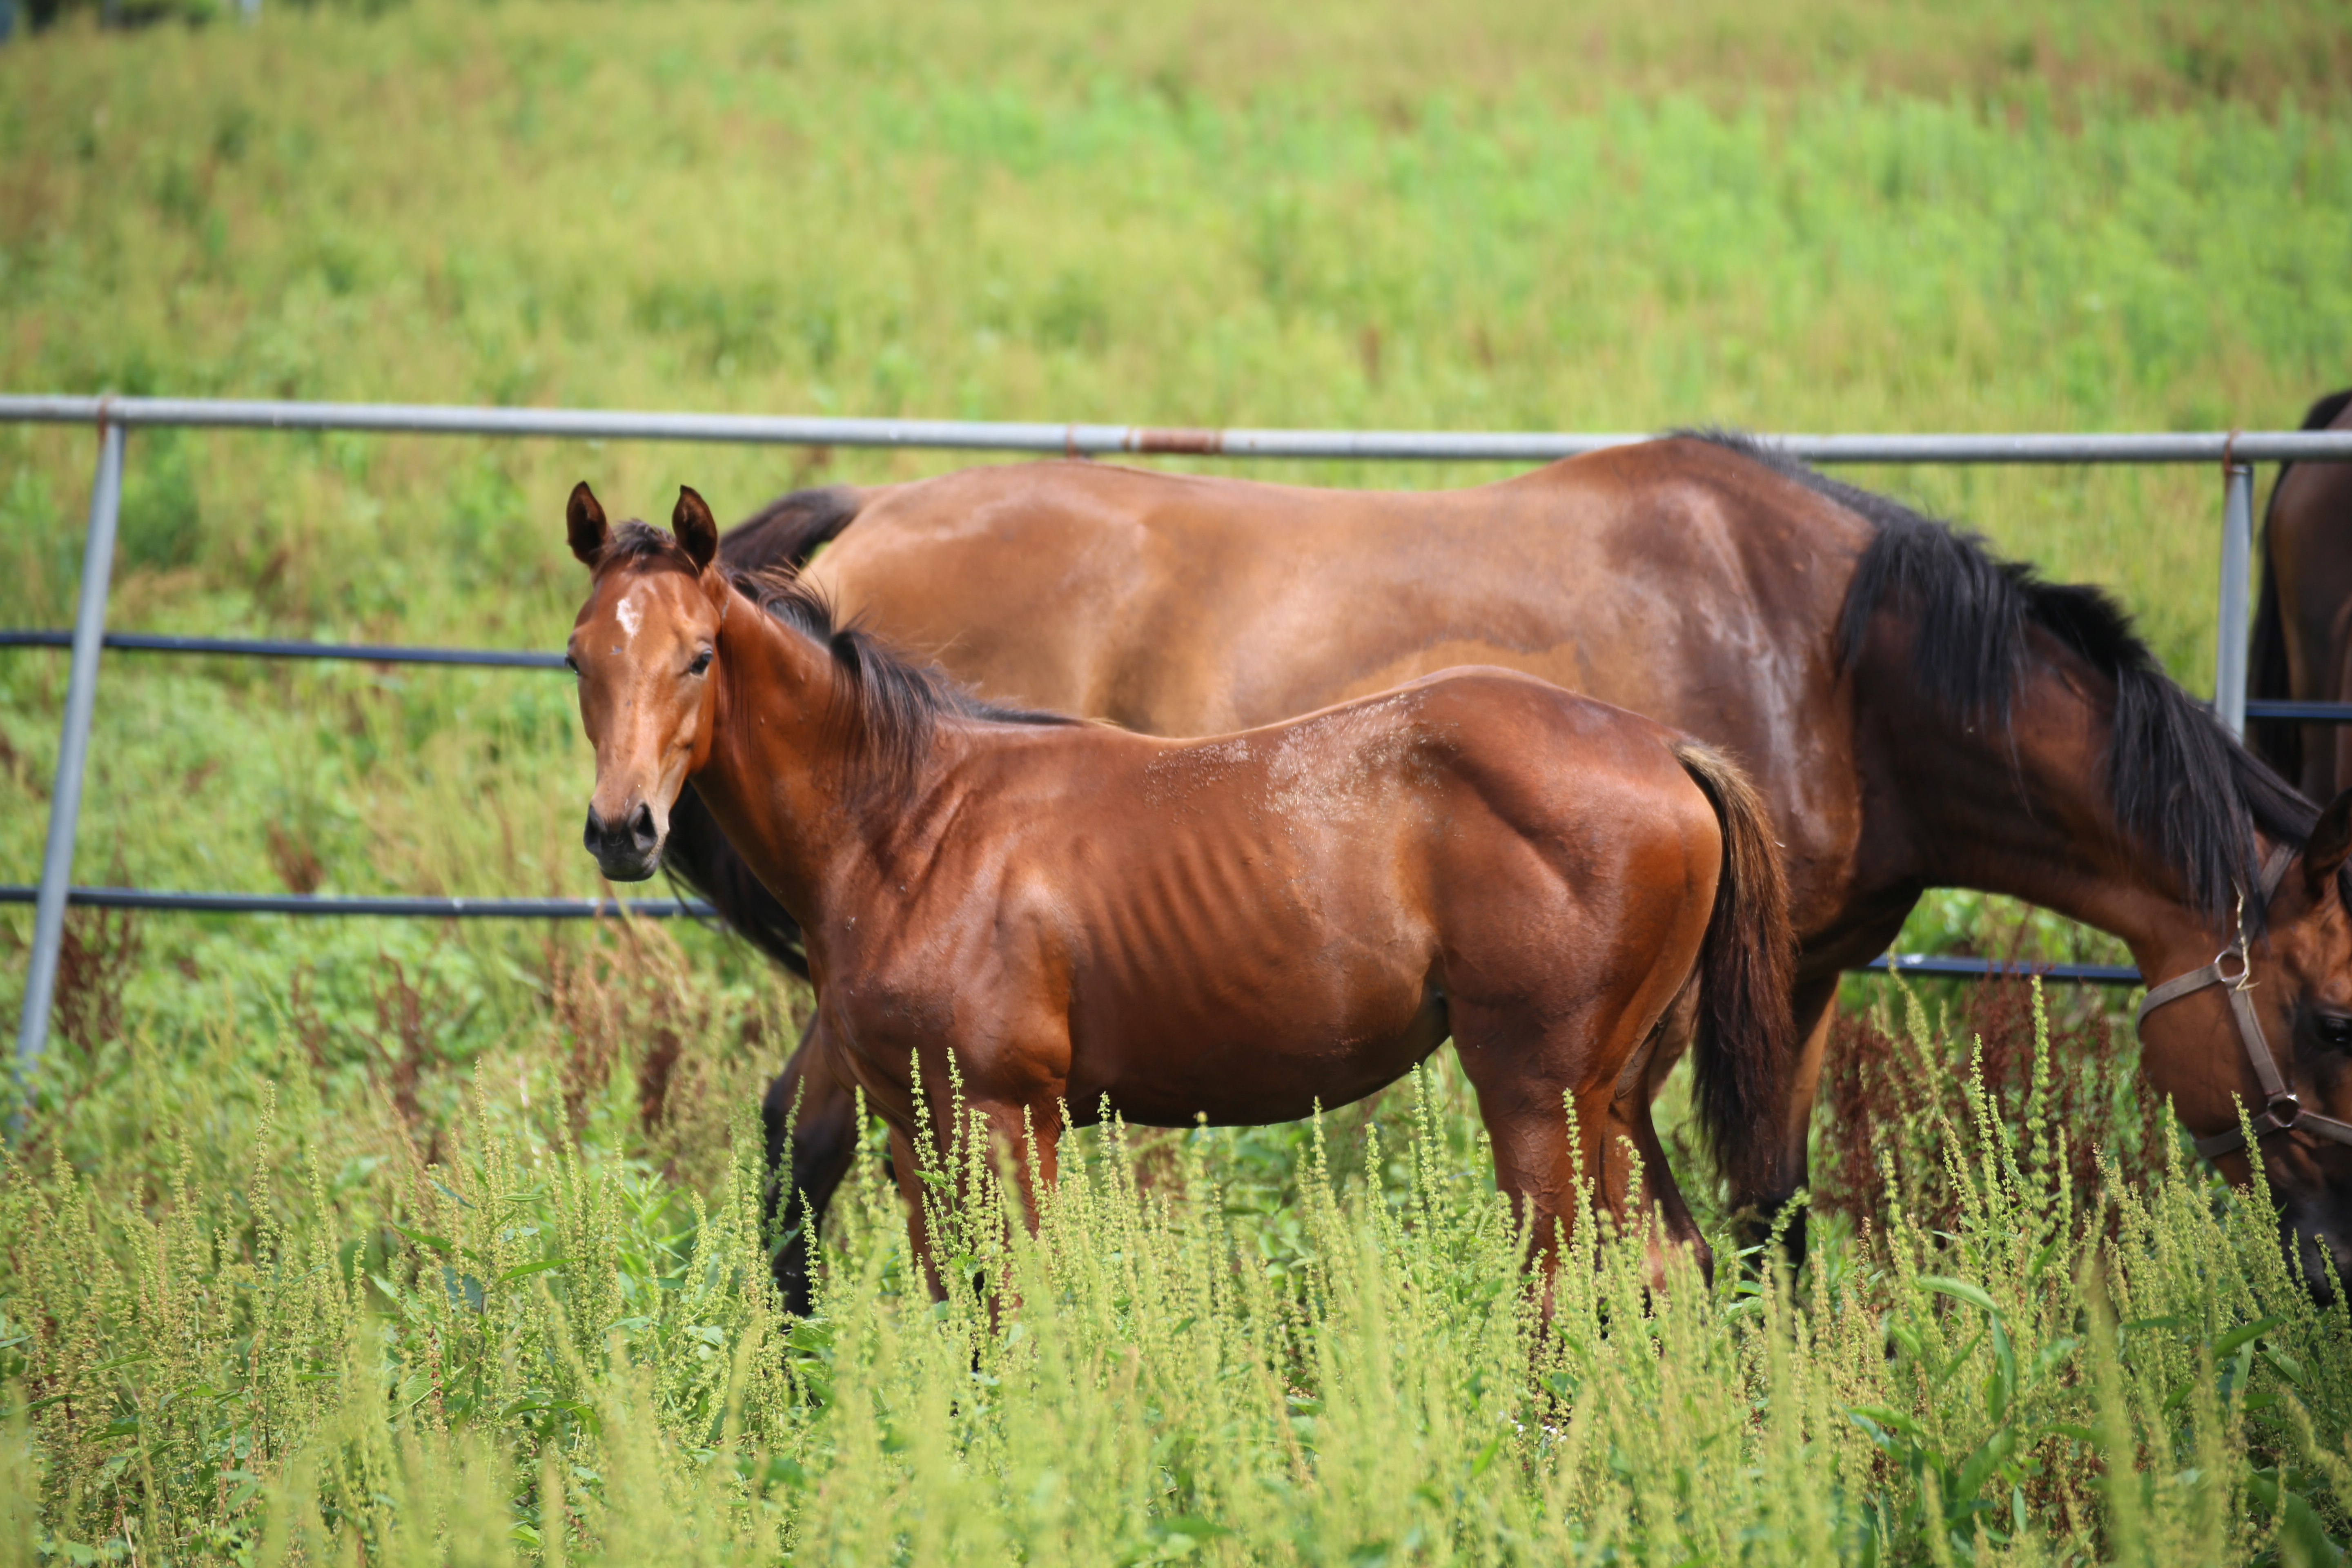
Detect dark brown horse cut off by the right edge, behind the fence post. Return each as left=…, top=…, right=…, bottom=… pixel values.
left=2246, top=390, right=2352, bottom=799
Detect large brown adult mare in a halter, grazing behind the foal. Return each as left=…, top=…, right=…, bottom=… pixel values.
left=670, top=435, right=2352, bottom=1293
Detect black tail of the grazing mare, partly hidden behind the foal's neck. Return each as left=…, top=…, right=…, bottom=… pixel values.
left=661, top=484, right=866, bottom=978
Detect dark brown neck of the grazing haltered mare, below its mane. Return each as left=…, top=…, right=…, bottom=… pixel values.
left=1896, top=663, right=2227, bottom=976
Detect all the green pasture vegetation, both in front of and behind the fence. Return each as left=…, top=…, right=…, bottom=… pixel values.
left=0, top=0, right=2352, bottom=1563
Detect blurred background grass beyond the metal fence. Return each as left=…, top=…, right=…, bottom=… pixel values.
left=0, top=0, right=2352, bottom=1105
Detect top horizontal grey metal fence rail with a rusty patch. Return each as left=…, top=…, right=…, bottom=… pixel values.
left=0, top=395, right=2352, bottom=463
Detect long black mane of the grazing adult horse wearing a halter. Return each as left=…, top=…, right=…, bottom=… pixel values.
left=1684, top=430, right=2319, bottom=931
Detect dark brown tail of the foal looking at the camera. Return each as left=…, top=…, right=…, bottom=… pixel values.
left=1675, top=740, right=1797, bottom=1204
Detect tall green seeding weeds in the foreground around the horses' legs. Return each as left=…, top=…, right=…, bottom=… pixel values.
left=0, top=987, right=2352, bottom=1563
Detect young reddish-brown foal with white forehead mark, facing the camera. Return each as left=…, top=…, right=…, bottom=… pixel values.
left=567, top=484, right=1792, bottom=1288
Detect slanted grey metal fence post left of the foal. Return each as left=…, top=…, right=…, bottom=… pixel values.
left=16, top=421, right=122, bottom=1081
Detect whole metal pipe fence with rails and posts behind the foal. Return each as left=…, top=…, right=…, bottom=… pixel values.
left=0, top=397, right=2352, bottom=1069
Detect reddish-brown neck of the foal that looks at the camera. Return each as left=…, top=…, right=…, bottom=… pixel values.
left=694, top=588, right=893, bottom=929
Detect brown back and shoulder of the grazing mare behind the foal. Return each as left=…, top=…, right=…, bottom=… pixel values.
left=811, top=440, right=1872, bottom=922
